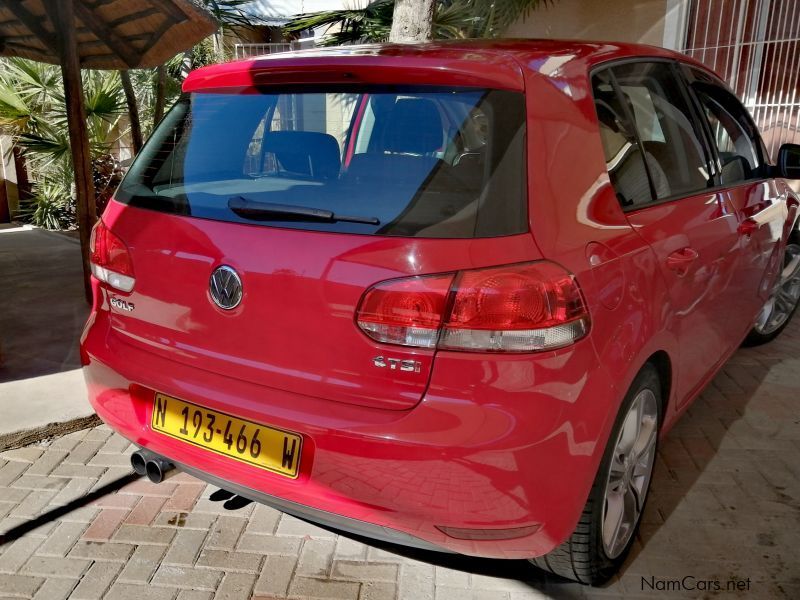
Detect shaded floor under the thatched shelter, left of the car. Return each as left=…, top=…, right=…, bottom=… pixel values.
left=0, top=227, right=89, bottom=383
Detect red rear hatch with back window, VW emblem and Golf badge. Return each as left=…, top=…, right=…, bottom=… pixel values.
left=103, top=72, right=536, bottom=409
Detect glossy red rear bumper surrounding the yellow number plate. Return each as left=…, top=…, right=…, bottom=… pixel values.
left=81, top=311, right=619, bottom=558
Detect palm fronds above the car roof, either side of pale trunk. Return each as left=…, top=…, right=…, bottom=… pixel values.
left=284, top=0, right=554, bottom=46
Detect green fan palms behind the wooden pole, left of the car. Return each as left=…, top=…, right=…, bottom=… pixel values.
left=0, top=0, right=258, bottom=229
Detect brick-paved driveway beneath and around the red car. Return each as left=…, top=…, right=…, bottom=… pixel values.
left=0, top=319, right=800, bottom=600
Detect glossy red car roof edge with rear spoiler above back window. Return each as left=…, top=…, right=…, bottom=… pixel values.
left=183, top=39, right=711, bottom=92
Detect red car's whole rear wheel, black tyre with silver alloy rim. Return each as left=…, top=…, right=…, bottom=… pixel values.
left=530, top=363, right=662, bottom=585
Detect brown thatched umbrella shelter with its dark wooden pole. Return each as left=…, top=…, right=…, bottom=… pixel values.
left=0, top=0, right=217, bottom=301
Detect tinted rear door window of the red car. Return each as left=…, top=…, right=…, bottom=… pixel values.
left=611, top=62, right=714, bottom=199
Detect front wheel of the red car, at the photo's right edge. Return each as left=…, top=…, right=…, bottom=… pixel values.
left=743, top=233, right=800, bottom=346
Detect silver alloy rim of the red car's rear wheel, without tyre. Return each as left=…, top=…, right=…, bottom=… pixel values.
left=602, top=388, right=658, bottom=559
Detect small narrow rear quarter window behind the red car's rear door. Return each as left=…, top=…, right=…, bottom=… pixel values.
left=592, top=70, right=652, bottom=207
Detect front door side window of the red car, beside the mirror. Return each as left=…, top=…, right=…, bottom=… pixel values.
left=692, top=83, right=762, bottom=185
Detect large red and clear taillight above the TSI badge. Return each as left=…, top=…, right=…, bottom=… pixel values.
left=357, top=261, right=589, bottom=352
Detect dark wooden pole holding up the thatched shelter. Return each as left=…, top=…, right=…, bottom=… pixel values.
left=48, top=0, right=97, bottom=303
